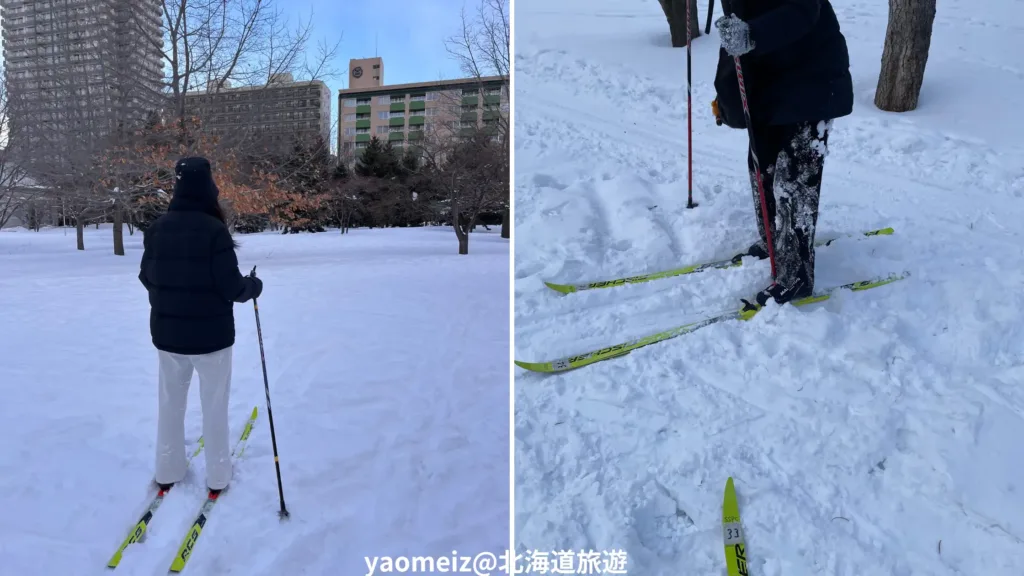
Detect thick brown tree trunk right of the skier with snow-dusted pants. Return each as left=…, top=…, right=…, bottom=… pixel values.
left=874, top=0, right=936, bottom=112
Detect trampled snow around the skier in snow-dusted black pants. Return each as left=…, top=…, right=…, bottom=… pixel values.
left=515, top=0, right=1024, bottom=576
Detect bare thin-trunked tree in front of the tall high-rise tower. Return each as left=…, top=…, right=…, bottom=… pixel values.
left=8, top=0, right=134, bottom=250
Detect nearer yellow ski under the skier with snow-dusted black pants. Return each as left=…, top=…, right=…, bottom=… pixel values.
left=515, top=272, right=910, bottom=373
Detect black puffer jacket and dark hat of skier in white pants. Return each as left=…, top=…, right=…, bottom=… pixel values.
left=138, top=158, right=262, bottom=355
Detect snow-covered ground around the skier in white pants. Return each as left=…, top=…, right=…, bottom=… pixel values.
left=0, top=224, right=509, bottom=576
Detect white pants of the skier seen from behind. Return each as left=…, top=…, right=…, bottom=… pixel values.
left=156, top=347, right=231, bottom=490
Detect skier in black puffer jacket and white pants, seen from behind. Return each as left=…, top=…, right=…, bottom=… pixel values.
left=138, top=158, right=263, bottom=491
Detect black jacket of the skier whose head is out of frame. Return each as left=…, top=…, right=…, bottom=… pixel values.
left=715, top=0, right=853, bottom=128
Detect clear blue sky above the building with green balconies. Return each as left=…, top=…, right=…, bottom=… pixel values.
left=292, top=0, right=468, bottom=90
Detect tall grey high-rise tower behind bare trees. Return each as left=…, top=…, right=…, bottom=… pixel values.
left=0, top=0, right=164, bottom=166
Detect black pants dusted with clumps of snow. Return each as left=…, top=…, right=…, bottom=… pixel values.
left=748, top=121, right=831, bottom=296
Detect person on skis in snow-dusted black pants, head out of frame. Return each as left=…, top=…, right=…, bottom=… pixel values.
left=715, top=0, right=853, bottom=305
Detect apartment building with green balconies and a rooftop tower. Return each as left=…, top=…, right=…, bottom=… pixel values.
left=338, top=57, right=509, bottom=153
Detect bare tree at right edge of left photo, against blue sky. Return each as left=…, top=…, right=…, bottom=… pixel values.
left=445, top=0, right=512, bottom=237
